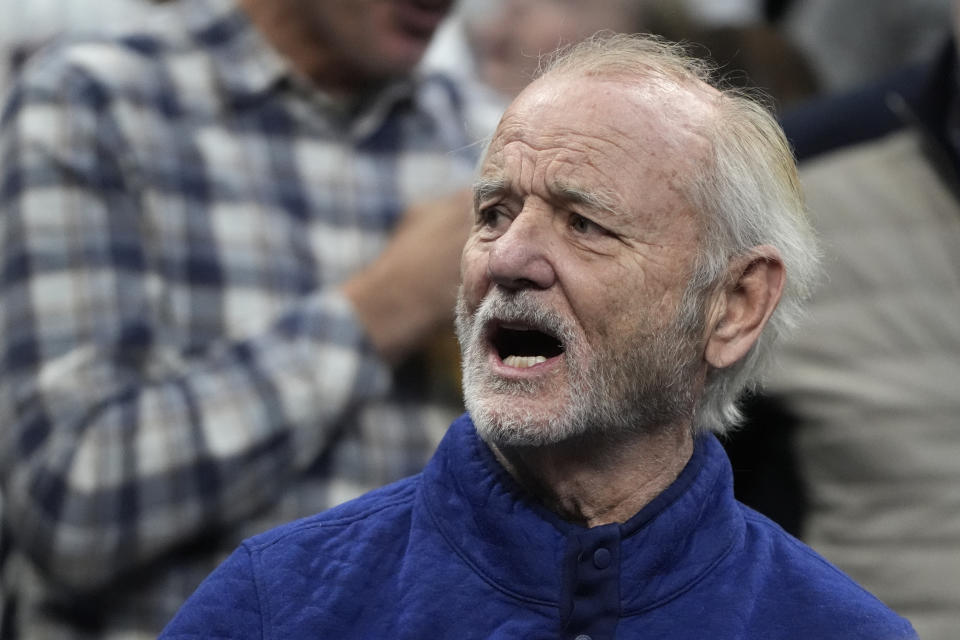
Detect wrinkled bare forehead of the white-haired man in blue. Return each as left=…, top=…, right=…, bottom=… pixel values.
left=482, top=75, right=715, bottom=196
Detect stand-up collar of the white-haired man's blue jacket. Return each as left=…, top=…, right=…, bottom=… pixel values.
left=420, top=415, right=745, bottom=613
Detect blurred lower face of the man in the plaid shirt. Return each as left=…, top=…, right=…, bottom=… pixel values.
left=304, top=0, right=453, bottom=84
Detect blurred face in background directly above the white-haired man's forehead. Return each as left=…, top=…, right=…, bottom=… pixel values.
left=466, top=0, right=640, bottom=98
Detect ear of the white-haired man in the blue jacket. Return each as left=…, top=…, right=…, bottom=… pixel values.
left=704, top=245, right=785, bottom=369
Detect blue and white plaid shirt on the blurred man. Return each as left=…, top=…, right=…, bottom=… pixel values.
left=0, top=0, right=476, bottom=639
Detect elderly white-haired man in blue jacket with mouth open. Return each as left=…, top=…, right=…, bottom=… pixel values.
left=158, top=36, right=915, bottom=640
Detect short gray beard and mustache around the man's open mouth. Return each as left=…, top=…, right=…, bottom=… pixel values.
left=456, top=287, right=699, bottom=447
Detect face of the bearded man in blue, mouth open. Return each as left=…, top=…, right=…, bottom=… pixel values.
left=457, top=77, right=705, bottom=445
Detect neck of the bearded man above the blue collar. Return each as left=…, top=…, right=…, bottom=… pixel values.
left=491, top=426, right=693, bottom=527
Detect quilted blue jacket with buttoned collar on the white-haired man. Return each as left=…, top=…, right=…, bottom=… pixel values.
left=162, top=416, right=916, bottom=640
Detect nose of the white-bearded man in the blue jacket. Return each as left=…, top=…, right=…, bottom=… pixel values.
left=487, top=207, right=557, bottom=289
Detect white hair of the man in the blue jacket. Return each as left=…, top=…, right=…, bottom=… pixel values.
left=539, top=33, right=819, bottom=433
